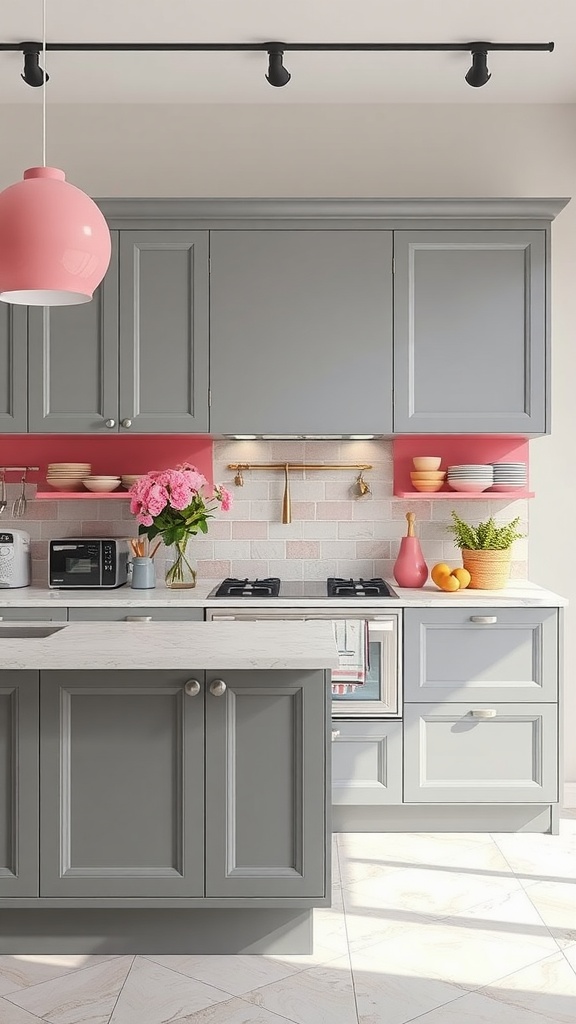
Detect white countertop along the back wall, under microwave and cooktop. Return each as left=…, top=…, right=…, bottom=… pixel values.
left=0, top=580, right=568, bottom=616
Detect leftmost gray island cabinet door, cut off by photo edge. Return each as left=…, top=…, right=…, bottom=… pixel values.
left=0, top=672, right=38, bottom=897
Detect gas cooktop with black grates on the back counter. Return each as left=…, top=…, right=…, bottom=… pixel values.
left=208, top=577, right=398, bottom=600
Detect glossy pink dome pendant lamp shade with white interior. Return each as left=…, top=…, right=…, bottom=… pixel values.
left=0, top=167, right=111, bottom=306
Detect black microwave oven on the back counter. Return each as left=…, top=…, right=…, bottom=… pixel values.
left=48, top=537, right=128, bottom=590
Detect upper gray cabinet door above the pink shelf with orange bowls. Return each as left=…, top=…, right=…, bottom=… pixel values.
left=394, top=230, right=547, bottom=434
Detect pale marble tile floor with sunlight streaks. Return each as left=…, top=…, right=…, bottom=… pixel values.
left=0, top=811, right=576, bottom=1024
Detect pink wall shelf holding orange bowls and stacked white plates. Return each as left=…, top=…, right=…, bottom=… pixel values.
left=393, top=434, right=535, bottom=502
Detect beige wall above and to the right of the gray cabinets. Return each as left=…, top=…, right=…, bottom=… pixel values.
left=0, top=96, right=576, bottom=781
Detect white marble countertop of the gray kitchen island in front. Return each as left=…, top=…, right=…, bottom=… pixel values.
left=0, top=621, right=338, bottom=673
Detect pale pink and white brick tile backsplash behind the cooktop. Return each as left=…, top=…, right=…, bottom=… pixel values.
left=2, top=439, right=528, bottom=583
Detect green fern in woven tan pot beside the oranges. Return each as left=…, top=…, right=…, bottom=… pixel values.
left=448, top=511, right=524, bottom=590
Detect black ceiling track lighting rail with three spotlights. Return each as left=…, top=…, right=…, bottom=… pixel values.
left=0, top=41, right=554, bottom=87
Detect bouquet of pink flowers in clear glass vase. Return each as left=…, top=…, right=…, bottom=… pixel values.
left=129, top=463, right=232, bottom=587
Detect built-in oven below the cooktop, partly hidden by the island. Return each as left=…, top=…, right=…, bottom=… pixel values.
left=206, top=602, right=402, bottom=718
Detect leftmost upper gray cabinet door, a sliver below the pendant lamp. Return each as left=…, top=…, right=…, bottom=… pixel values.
left=0, top=302, right=28, bottom=434
